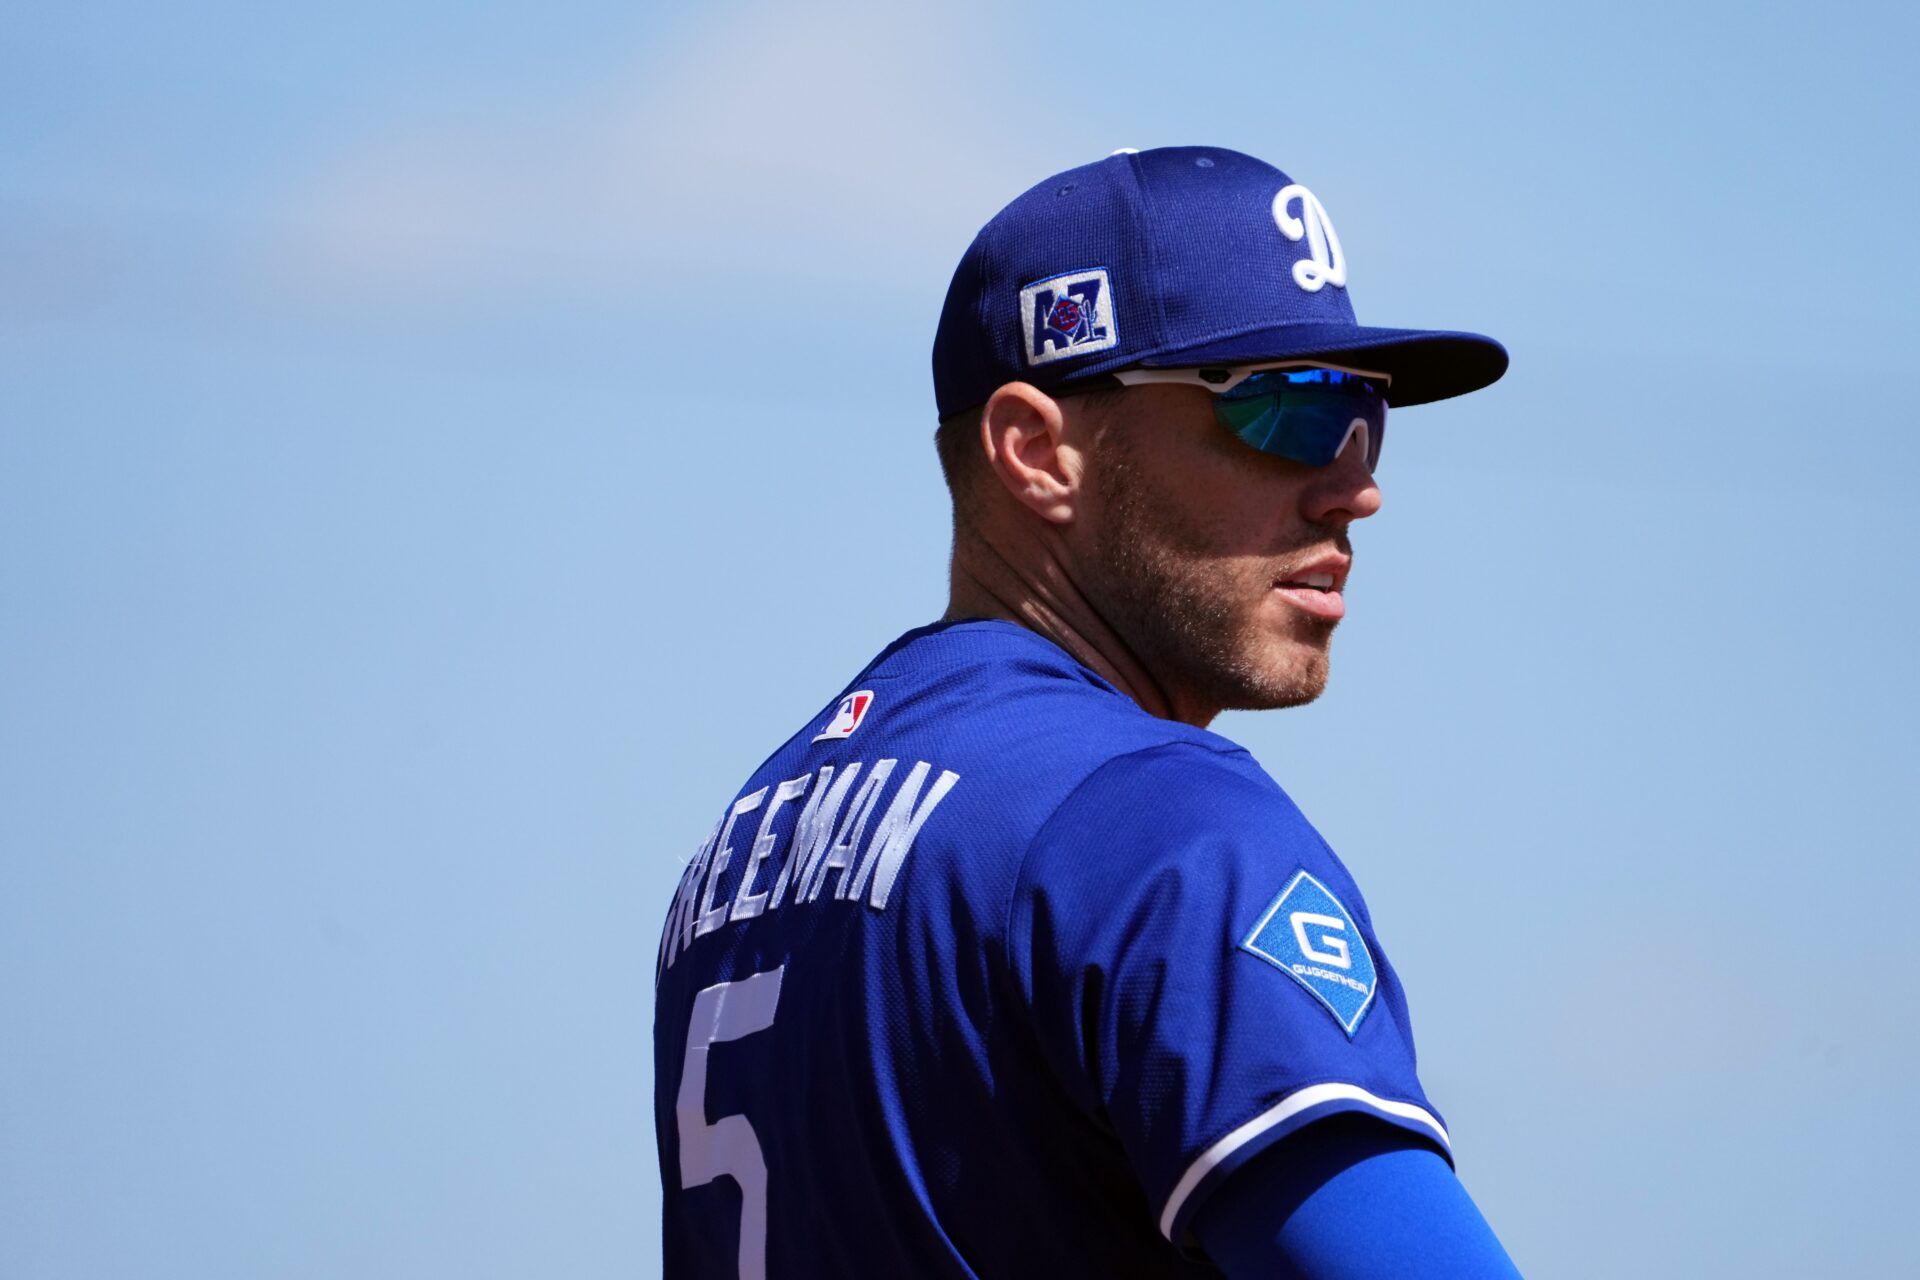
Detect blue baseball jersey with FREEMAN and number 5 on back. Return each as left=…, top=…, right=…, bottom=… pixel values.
left=653, top=622, right=1448, bottom=1280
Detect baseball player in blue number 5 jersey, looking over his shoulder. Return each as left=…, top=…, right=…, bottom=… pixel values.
left=655, top=148, right=1515, bottom=1280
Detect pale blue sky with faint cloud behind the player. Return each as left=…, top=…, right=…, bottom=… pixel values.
left=0, top=4, right=1920, bottom=1280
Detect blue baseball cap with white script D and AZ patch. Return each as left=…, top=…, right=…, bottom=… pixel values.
left=933, top=146, right=1507, bottom=418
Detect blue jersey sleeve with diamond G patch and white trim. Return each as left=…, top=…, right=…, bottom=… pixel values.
left=1008, top=743, right=1452, bottom=1244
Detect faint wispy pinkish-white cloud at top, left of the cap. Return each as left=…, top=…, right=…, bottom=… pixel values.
left=264, top=4, right=1075, bottom=299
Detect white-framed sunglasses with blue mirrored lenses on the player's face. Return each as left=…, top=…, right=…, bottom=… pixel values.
left=1108, top=363, right=1390, bottom=472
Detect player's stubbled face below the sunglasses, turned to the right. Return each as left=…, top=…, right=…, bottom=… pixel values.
left=1073, top=386, right=1380, bottom=722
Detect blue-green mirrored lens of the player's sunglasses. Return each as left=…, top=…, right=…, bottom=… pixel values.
left=1213, top=368, right=1386, bottom=472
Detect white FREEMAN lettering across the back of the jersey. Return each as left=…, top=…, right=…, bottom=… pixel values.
left=655, top=760, right=960, bottom=983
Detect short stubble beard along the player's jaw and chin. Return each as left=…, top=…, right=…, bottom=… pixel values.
left=1089, top=432, right=1344, bottom=710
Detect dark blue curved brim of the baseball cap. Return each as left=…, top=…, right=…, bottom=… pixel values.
left=1139, top=324, right=1507, bottom=409
